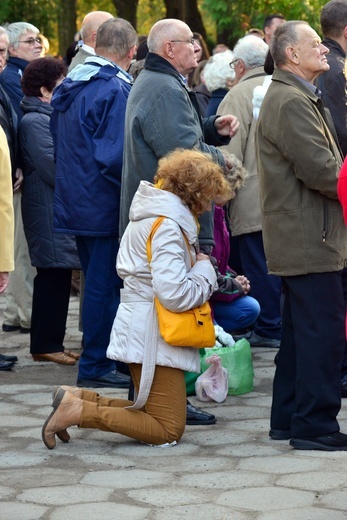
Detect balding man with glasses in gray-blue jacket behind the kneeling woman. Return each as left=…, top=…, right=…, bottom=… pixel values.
left=120, top=19, right=238, bottom=424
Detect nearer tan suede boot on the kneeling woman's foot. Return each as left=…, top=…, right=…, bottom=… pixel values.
left=42, top=388, right=83, bottom=450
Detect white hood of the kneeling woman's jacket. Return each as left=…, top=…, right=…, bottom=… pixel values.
left=129, top=181, right=197, bottom=244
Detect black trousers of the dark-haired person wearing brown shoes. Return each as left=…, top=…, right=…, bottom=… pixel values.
left=30, top=267, right=72, bottom=354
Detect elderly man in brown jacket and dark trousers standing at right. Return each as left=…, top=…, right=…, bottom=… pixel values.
left=256, top=21, right=347, bottom=451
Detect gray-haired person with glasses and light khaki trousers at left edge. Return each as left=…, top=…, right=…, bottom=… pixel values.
left=0, top=22, right=42, bottom=333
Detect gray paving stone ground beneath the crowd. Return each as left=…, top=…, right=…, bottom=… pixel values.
left=0, top=296, right=347, bottom=520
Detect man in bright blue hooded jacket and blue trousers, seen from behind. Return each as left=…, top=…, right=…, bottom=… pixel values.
left=51, top=18, right=137, bottom=388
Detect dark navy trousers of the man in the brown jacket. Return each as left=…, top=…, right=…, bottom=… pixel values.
left=271, top=271, right=345, bottom=437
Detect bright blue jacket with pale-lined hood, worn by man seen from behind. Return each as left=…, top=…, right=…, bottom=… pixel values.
left=51, top=56, right=131, bottom=237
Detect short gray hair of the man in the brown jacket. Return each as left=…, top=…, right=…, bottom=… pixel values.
left=270, top=20, right=308, bottom=67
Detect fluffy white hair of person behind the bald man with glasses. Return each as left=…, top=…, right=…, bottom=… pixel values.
left=203, top=50, right=235, bottom=92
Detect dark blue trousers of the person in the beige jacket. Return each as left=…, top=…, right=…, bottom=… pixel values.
left=238, top=231, right=282, bottom=339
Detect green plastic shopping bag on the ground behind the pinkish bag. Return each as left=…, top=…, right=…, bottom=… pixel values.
left=201, top=338, right=254, bottom=395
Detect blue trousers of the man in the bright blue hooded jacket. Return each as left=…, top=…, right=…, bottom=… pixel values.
left=76, top=236, right=123, bottom=379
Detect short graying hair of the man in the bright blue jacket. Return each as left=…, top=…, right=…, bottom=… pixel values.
left=95, top=18, right=137, bottom=58
